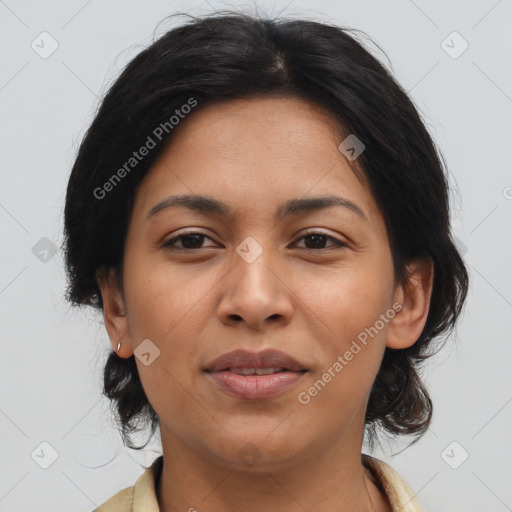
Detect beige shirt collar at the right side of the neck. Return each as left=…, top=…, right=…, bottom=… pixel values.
left=363, top=454, right=423, bottom=512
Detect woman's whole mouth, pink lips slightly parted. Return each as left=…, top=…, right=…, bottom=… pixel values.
left=203, top=350, right=308, bottom=400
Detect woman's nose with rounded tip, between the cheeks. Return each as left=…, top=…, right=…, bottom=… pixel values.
left=217, top=244, right=294, bottom=331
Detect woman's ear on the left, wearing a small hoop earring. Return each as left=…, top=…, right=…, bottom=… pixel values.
left=96, top=267, right=133, bottom=357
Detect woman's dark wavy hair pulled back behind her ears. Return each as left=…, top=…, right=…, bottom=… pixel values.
left=64, top=12, right=468, bottom=448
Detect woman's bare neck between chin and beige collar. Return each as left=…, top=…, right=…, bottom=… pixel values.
left=158, top=420, right=390, bottom=512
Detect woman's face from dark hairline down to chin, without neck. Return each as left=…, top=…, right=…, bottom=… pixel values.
left=102, top=98, right=421, bottom=470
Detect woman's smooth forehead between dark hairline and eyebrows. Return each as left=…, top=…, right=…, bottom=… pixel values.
left=135, top=97, right=379, bottom=228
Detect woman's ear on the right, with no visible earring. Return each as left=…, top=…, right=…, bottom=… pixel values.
left=386, top=258, right=434, bottom=349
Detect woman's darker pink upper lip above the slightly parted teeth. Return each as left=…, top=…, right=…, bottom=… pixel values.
left=205, top=349, right=306, bottom=372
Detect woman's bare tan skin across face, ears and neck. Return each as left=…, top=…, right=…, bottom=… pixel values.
left=99, top=98, right=432, bottom=512
